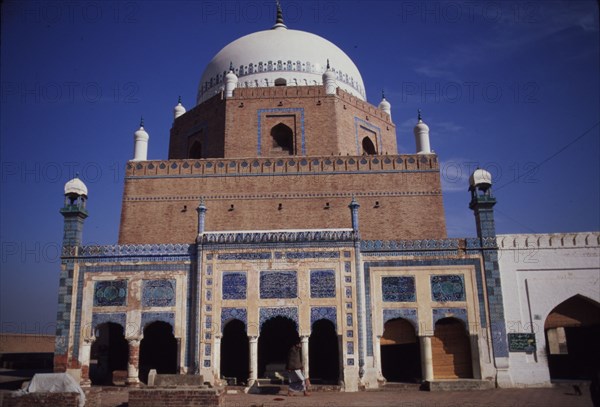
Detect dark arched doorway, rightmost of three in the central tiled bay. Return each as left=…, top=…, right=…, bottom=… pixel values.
left=308, top=319, right=340, bottom=384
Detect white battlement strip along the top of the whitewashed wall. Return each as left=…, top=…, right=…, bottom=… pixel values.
left=497, top=232, right=600, bottom=250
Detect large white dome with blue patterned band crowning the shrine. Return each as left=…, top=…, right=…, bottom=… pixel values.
left=196, top=25, right=366, bottom=104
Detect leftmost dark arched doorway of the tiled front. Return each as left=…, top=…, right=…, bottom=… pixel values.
left=90, top=322, right=129, bottom=386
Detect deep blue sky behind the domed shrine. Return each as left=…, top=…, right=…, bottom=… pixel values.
left=0, top=0, right=600, bottom=334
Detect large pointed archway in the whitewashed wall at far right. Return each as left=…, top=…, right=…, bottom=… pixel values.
left=544, top=295, right=600, bottom=380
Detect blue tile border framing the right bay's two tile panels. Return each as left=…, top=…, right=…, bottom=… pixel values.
left=363, top=262, right=486, bottom=356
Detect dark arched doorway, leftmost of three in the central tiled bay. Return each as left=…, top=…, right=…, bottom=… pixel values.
left=221, top=319, right=250, bottom=385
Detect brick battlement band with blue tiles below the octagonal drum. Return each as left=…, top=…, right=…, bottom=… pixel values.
left=125, top=154, right=439, bottom=178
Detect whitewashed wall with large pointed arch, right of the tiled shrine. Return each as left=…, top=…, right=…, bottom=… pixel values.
left=498, top=232, right=600, bottom=387
